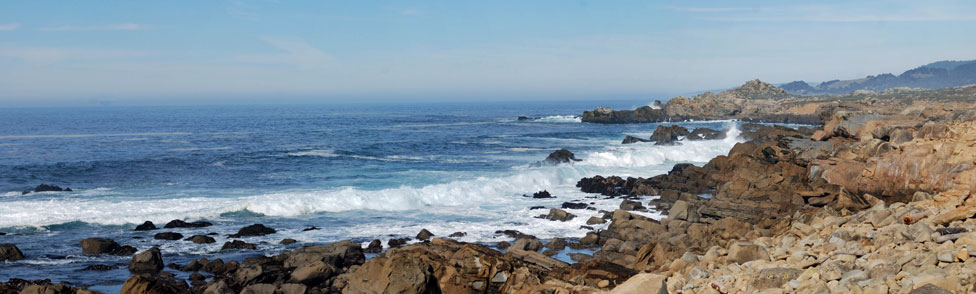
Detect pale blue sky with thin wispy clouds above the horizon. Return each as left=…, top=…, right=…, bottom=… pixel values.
left=0, top=0, right=976, bottom=107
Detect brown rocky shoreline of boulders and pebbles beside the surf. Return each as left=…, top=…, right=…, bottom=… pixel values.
left=0, top=81, right=976, bottom=293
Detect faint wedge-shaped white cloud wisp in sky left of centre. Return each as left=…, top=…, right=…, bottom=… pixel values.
left=236, top=36, right=332, bottom=68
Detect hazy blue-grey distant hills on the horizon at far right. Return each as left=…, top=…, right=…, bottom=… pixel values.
left=780, top=60, right=976, bottom=95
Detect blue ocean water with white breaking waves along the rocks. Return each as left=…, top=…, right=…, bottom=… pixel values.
left=0, top=101, right=738, bottom=285
